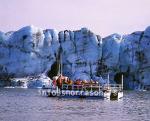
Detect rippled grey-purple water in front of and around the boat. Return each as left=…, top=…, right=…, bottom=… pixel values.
left=0, top=88, right=150, bottom=121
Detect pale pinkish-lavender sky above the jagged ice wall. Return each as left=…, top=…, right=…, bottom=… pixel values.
left=0, top=0, right=150, bottom=37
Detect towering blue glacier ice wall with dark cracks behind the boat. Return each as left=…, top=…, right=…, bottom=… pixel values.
left=0, top=26, right=150, bottom=89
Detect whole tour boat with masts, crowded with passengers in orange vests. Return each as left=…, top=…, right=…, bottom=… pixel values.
left=41, top=45, right=123, bottom=100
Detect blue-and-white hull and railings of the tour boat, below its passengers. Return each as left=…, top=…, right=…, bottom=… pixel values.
left=42, top=84, right=123, bottom=99
